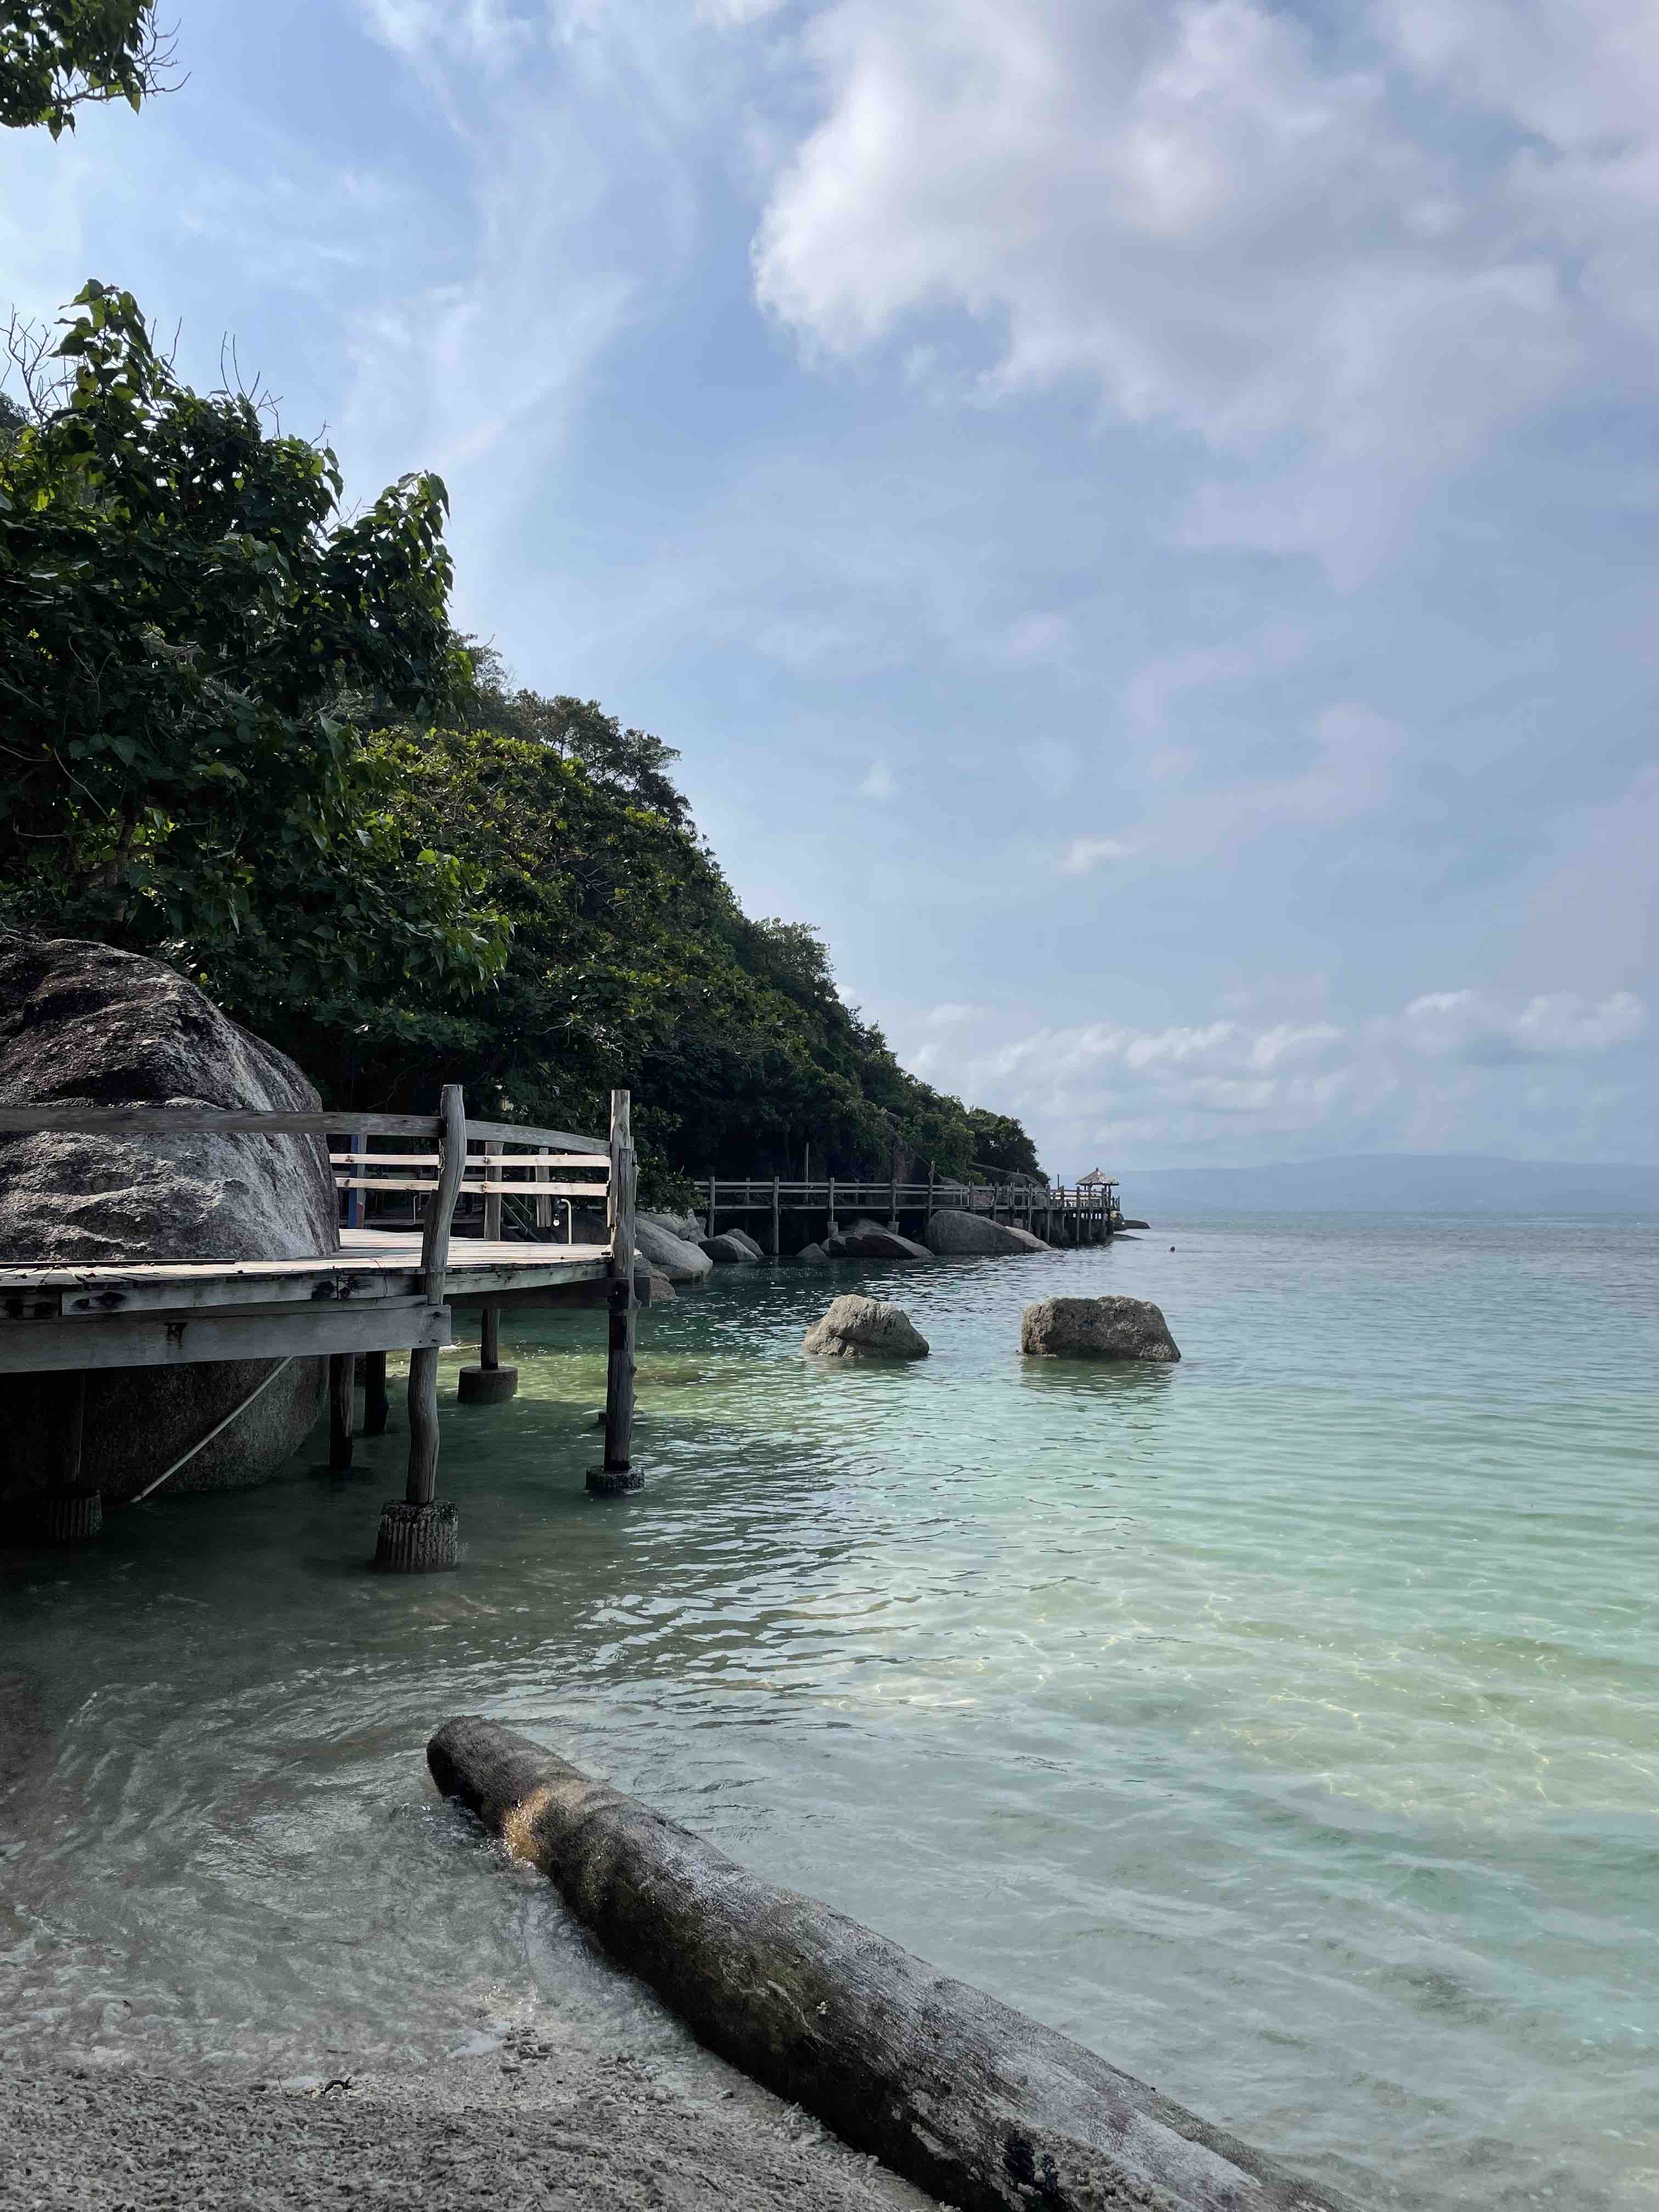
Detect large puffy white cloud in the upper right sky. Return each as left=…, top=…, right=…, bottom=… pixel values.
left=754, top=0, right=1659, bottom=566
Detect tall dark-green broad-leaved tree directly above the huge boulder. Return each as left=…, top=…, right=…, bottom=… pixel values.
left=0, top=283, right=502, bottom=1020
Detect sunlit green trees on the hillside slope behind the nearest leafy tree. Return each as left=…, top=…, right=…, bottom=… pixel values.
left=281, top=690, right=1040, bottom=1197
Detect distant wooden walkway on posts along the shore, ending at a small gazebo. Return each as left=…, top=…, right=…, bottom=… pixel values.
left=699, top=1175, right=1124, bottom=1254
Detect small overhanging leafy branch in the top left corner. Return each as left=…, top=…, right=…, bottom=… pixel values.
left=0, top=0, right=170, bottom=137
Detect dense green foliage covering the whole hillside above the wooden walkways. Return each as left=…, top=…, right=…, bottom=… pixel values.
left=0, top=285, right=1037, bottom=1197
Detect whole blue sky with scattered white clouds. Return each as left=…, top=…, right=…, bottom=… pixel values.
left=0, top=0, right=1659, bottom=1175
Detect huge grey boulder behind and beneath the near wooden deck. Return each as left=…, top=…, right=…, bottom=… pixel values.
left=0, top=936, right=338, bottom=1498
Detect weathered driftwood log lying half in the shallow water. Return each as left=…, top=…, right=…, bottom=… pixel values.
left=427, top=1717, right=1342, bottom=2212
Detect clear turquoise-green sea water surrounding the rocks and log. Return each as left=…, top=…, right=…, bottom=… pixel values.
left=0, top=1217, right=1659, bottom=2208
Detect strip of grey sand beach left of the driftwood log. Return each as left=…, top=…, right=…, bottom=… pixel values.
left=0, top=2024, right=938, bottom=2212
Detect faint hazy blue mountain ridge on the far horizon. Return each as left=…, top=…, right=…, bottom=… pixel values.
left=1121, top=1153, right=1659, bottom=1219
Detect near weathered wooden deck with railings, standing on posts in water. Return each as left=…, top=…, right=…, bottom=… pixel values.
left=0, top=1084, right=650, bottom=1571
